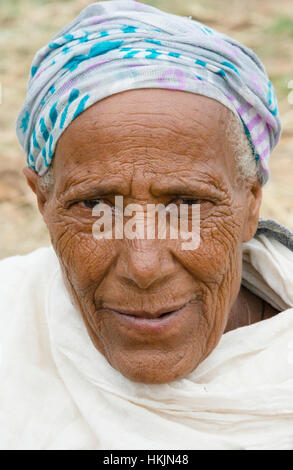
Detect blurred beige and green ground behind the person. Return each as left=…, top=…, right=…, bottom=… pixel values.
left=0, top=0, right=293, bottom=258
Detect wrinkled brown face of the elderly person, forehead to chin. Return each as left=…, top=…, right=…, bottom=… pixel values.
left=29, top=90, right=258, bottom=383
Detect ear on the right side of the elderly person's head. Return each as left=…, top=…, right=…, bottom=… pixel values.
left=243, top=181, right=262, bottom=242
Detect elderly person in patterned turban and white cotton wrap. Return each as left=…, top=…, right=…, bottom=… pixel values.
left=0, top=0, right=293, bottom=449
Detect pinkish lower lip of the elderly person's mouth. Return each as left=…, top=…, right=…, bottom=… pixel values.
left=106, top=303, right=189, bottom=333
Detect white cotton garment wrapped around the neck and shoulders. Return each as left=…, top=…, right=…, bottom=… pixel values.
left=0, top=235, right=293, bottom=450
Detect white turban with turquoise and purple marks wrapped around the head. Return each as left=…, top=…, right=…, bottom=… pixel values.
left=17, top=0, right=281, bottom=184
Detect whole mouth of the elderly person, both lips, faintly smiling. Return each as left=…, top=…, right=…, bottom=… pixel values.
left=102, top=302, right=190, bottom=333
